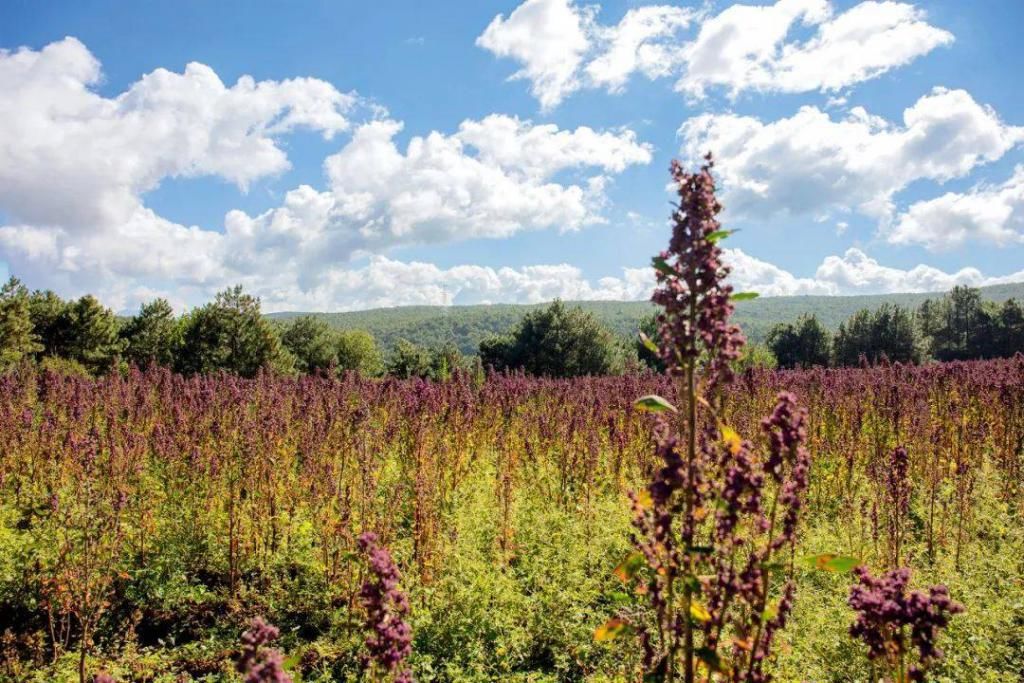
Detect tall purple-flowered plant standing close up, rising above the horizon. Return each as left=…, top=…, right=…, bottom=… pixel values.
left=621, top=156, right=809, bottom=683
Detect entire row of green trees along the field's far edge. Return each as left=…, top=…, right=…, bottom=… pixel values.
left=0, top=278, right=1024, bottom=381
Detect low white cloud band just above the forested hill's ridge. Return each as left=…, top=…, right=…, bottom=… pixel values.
left=255, top=249, right=1024, bottom=310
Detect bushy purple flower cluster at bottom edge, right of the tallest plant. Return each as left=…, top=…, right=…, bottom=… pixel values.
left=849, top=566, right=964, bottom=683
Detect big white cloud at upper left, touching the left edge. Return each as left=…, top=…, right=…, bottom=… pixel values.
left=0, top=38, right=356, bottom=230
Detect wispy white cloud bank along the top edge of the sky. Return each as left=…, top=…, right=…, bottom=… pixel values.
left=477, top=0, right=953, bottom=109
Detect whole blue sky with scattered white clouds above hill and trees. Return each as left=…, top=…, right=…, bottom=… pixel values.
left=0, top=0, right=1024, bottom=312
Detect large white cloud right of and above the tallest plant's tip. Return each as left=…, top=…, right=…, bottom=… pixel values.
left=679, top=88, right=1024, bottom=218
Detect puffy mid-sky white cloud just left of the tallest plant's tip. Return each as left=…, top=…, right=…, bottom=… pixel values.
left=227, top=115, right=651, bottom=266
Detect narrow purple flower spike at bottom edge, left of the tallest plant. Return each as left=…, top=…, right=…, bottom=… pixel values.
left=358, top=531, right=413, bottom=683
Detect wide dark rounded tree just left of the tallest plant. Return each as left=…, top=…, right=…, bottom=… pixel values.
left=480, top=300, right=623, bottom=377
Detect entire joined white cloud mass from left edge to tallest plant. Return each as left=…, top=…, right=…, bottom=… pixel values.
left=0, top=38, right=651, bottom=308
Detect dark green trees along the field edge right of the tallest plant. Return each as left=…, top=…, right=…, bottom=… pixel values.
left=767, top=287, right=1024, bottom=368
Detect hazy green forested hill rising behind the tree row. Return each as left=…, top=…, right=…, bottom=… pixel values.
left=269, top=283, right=1024, bottom=353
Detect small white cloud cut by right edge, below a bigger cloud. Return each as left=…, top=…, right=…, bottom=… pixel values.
left=888, top=166, right=1024, bottom=250
